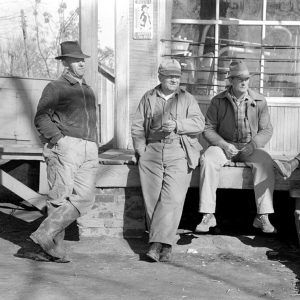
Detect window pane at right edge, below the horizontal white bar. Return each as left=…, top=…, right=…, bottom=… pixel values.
left=264, top=26, right=300, bottom=97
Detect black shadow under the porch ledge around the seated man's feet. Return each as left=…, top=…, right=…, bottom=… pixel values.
left=178, top=189, right=300, bottom=294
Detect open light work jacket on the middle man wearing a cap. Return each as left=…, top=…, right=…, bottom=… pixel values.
left=131, top=85, right=204, bottom=169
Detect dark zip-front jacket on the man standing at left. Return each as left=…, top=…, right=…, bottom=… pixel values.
left=34, top=73, right=97, bottom=144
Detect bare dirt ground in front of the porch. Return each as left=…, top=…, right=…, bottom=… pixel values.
left=0, top=199, right=300, bottom=300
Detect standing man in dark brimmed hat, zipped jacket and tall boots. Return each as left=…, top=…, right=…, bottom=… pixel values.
left=30, top=41, right=98, bottom=262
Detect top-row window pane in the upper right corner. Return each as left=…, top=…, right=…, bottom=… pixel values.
left=267, top=0, right=300, bottom=21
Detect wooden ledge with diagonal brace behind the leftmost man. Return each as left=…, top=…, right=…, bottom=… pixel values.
left=0, top=144, right=48, bottom=210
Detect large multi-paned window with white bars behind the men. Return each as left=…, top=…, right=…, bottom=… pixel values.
left=164, top=0, right=300, bottom=97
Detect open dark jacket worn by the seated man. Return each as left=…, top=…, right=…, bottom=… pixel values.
left=203, top=90, right=273, bottom=148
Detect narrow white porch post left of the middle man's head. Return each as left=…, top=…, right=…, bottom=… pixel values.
left=114, top=0, right=130, bottom=149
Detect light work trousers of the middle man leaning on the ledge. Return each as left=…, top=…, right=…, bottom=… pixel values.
left=139, top=141, right=191, bottom=245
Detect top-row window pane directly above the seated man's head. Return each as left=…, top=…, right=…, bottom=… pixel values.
left=220, top=0, right=263, bottom=20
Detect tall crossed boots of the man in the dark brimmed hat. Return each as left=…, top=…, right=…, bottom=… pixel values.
left=30, top=202, right=79, bottom=259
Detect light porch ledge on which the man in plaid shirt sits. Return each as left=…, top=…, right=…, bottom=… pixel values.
left=96, top=149, right=300, bottom=243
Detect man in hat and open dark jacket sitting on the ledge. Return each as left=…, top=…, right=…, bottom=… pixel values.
left=195, top=60, right=276, bottom=233
